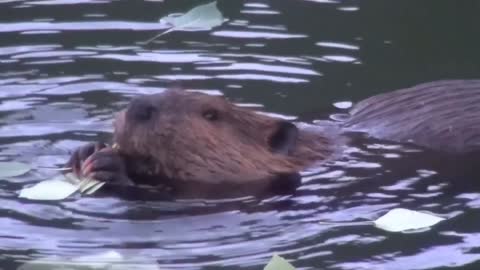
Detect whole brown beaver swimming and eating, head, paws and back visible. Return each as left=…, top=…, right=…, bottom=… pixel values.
left=67, top=80, right=480, bottom=196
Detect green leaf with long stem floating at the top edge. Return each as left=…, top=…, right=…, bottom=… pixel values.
left=144, top=1, right=224, bottom=44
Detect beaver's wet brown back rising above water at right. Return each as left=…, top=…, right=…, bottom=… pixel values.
left=343, top=80, right=480, bottom=153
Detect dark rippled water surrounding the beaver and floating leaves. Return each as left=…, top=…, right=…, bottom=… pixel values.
left=0, top=0, right=480, bottom=270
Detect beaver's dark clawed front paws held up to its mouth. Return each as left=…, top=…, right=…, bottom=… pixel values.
left=67, top=143, right=133, bottom=185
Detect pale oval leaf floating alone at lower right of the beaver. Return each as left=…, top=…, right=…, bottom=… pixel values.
left=374, top=208, right=445, bottom=232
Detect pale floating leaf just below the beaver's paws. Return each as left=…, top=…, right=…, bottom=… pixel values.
left=19, top=176, right=78, bottom=200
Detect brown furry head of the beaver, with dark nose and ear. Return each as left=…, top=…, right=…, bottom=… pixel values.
left=114, top=90, right=331, bottom=183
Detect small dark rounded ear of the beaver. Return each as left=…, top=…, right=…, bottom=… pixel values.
left=268, top=121, right=298, bottom=155
